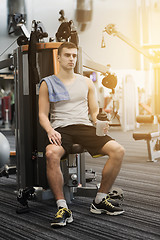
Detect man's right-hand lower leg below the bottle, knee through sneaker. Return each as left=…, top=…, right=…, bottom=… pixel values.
left=90, top=140, right=124, bottom=215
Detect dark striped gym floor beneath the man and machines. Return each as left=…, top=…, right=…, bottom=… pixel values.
left=0, top=128, right=160, bottom=240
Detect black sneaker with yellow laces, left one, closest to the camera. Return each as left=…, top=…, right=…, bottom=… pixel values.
left=51, top=208, right=73, bottom=227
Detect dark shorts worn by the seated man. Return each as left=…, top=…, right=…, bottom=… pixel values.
left=55, top=124, right=114, bottom=156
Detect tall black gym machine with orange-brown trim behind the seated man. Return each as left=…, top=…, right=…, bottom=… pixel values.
left=2, top=16, right=123, bottom=213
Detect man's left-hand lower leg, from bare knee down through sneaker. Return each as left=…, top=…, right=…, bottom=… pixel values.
left=46, top=144, right=73, bottom=227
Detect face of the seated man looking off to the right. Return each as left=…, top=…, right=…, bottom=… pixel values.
left=58, top=48, right=77, bottom=70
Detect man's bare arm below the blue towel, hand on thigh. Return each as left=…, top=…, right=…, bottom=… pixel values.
left=39, top=81, right=61, bottom=145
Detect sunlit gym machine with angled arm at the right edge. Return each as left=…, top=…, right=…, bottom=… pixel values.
left=102, top=24, right=160, bottom=162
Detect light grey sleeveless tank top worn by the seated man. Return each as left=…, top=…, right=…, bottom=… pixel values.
left=50, top=74, right=92, bottom=128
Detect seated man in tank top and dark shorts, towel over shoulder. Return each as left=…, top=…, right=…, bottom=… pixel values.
left=39, top=42, right=124, bottom=226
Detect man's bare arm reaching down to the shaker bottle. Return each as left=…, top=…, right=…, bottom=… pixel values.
left=86, top=78, right=99, bottom=124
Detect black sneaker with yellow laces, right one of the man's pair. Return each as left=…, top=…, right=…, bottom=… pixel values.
left=90, top=198, right=124, bottom=215
